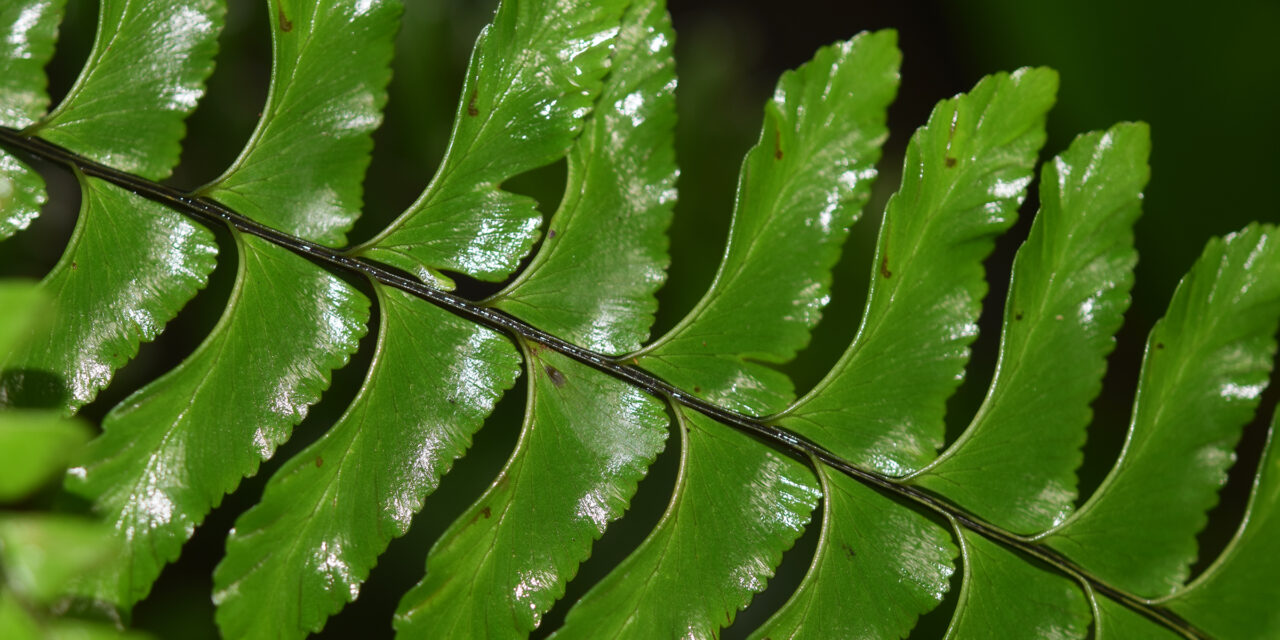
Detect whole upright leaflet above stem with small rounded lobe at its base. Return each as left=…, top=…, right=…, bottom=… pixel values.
left=640, top=31, right=901, bottom=415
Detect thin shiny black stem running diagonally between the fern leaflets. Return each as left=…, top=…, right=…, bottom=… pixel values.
left=0, top=127, right=1210, bottom=640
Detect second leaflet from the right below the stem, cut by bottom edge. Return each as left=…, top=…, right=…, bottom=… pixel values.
left=946, top=527, right=1092, bottom=640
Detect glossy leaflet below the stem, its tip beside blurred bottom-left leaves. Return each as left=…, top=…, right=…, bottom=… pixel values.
left=67, top=237, right=369, bottom=608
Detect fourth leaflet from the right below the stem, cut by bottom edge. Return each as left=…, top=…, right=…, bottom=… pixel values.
left=552, top=410, right=820, bottom=640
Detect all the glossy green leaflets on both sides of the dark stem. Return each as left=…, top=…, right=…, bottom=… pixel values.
left=0, top=0, right=1280, bottom=639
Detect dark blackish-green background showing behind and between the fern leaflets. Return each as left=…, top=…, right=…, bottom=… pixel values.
left=0, top=0, right=1280, bottom=637
